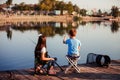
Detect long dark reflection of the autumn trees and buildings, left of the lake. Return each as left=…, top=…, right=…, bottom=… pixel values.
left=1, top=22, right=78, bottom=39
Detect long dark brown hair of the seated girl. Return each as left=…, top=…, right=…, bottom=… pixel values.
left=35, top=35, right=46, bottom=53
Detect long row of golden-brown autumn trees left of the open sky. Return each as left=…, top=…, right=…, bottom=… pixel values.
left=6, top=0, right=80, bottom=14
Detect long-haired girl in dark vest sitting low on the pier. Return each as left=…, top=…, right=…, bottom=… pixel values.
left=35, top=35, right=55, bottom=74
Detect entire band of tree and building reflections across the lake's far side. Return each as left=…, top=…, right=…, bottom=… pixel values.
left=0, top=21, right=120, bottom=40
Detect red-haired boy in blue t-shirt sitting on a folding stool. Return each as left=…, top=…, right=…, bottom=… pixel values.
left=63, top=29, right=81, bottom=73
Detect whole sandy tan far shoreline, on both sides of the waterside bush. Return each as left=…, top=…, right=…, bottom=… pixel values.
left=0, top=15, right=120, bottom=22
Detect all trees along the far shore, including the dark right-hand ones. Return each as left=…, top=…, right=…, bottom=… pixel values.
left=3, top=0, right=120, bottom=17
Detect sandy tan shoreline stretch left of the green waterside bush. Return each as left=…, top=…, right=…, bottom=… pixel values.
left=0, top=15, right=73, bottom=22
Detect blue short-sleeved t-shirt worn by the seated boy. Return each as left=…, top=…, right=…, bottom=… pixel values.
left=65, top=38, right=81, bottom=55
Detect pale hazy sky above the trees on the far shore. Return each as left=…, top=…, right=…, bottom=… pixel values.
left=0, top=0, right=120, bottom=11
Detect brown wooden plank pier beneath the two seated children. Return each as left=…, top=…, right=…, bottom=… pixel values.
left=0, top=60, right=120, bottom=80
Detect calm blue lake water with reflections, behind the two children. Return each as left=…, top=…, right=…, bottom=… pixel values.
left=0, top=22, right=120, bottom=71
